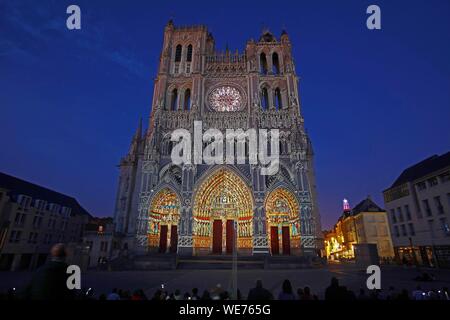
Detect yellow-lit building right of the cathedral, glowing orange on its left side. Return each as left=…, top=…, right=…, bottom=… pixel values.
left=325, top=198, right=394, bottom=260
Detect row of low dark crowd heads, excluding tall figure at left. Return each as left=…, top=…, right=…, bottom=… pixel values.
left=0, top=277, right=450, bottom=301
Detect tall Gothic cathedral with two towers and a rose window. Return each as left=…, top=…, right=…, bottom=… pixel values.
left=114, top=21, right=323, bottom=255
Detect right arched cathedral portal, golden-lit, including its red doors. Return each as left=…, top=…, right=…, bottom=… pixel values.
left=265, top=188, right=300, bottom=255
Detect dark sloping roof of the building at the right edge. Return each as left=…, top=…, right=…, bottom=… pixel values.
left=389, top=151, right=450, bottom=189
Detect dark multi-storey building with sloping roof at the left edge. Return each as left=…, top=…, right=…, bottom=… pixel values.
left=0, top=172, right=91, bottom=271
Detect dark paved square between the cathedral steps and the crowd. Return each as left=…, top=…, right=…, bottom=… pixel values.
left=0, top=264, right=450, bottom=298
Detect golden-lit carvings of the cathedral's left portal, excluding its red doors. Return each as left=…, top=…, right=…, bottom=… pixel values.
left=148, top=188, right=180, bottom=247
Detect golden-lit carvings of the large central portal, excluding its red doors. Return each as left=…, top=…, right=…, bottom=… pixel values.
left=193, top=169, right=253, bottom=248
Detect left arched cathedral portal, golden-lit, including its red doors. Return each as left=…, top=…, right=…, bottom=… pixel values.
left=148, top=188, right=180, bottom=253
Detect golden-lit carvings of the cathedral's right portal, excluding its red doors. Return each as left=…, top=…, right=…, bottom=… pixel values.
left=265, top=188, right=301, bottom=248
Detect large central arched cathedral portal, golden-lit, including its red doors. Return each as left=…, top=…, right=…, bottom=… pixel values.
left=193, top=168, right=253, bottom=254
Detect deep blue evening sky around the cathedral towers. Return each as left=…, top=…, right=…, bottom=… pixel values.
left=0, top=0, right=450, bottom=227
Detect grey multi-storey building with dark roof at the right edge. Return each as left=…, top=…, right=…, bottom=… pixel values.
left=383, top=152, right=450, bottom=268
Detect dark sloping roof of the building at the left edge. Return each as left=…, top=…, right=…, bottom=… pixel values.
left=0, top=172, right=91, bottom=217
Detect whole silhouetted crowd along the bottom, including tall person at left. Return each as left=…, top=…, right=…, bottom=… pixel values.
left=0, top=244, right=450, bottom=301
